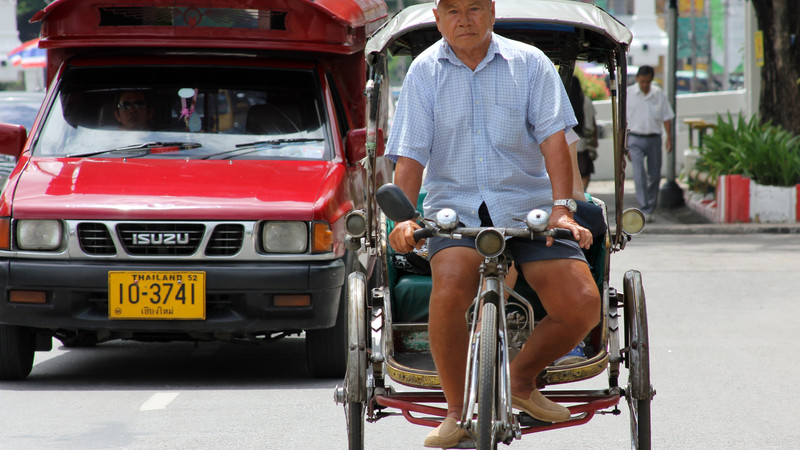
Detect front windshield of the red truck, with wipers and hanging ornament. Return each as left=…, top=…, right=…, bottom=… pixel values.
left=34, top=65, right=331, bottom=160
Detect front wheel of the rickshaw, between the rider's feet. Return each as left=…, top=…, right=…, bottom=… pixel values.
left=477, top=303, right=497, bottom=450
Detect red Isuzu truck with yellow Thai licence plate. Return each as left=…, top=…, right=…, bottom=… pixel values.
left=0, top=0, right=389, bottom=379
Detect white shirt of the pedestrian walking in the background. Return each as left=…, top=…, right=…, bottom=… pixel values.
left=626, top=83, right=675, bottom=134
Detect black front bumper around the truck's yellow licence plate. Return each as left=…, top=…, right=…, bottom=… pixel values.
left=0, top=259, right=345, bottom=335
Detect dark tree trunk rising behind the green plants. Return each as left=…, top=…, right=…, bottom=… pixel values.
left=751, top=0, right=800, bottom=134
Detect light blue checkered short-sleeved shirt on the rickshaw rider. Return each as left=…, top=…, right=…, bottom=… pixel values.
left=386, top=34, right=577, bottom=227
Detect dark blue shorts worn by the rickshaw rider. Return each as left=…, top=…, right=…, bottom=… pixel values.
left=428, top=204, right=586, bottom=264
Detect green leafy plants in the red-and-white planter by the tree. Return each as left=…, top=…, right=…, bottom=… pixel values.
left=696, top=113, right=800, bottom=186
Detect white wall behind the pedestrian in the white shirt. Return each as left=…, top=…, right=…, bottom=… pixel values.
left=592, top=89, right=749, bottom=180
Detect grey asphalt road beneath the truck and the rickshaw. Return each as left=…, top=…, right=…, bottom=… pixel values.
left=0, top=234, right=800, bottom=449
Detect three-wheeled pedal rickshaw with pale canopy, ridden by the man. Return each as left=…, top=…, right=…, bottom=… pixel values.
left=334, top=0, right=655, bottom=449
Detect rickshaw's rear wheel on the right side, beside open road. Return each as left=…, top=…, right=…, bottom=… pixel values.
left=624, top=270, right=654, bottom=449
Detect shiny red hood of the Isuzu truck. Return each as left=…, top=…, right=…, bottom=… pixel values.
left=13, top=158, right=344, bottom=220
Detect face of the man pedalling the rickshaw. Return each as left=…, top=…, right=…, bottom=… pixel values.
left=433, top=0, right=494, bottom=53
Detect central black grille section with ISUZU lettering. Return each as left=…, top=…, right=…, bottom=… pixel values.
left=117, top=223, right=205, bottom=256
